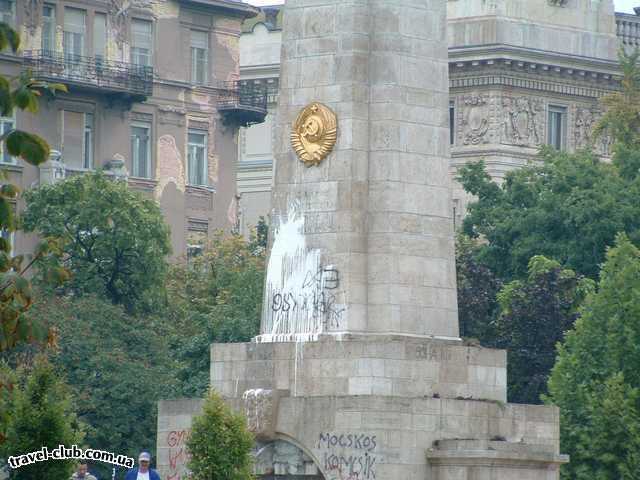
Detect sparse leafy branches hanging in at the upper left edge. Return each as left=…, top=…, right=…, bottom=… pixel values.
left=0, top=22, right=66, bottom=352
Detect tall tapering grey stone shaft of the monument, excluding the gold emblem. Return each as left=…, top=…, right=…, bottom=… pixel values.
left=262, top=0, right=458, bottom=339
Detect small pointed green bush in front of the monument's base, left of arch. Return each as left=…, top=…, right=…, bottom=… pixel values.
left=187, top=392, right=254, bottom=480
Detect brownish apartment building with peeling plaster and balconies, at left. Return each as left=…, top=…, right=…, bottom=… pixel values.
left=0, top=0, right=265, bottom=256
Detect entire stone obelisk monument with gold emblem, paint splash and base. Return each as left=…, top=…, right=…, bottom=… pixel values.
left=211, top=0, right=566, bottom=480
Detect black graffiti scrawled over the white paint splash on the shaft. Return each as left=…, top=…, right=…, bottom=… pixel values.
left=271, top=267, right=346, bottom=328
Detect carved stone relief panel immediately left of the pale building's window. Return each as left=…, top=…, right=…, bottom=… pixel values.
left=501, top=96, right=545, bottom=147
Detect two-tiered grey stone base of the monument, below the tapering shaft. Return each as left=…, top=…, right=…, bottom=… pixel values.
left=211, top=335, right=567, bottom=480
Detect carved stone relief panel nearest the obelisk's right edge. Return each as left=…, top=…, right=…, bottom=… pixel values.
left=458, top=94, right=495, bottom=145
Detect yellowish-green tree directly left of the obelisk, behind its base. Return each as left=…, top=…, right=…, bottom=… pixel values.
left=167, top=234, right=265, bottom=396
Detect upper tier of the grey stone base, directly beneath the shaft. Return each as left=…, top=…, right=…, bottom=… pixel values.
left=211, top=335, right=507, bottom=404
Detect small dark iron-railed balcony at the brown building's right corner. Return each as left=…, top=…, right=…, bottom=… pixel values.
left=218, top=81, right=267, bottom=127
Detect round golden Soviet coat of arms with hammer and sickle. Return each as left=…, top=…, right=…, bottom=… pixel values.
left=291, top=102, right=338, bottom=167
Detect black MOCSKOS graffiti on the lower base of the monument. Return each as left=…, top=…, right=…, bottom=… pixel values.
left=316, top=433, right=379, bottom=480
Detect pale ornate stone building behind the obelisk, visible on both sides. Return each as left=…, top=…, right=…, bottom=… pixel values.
left=238, top=0, right=640, bottom=233
